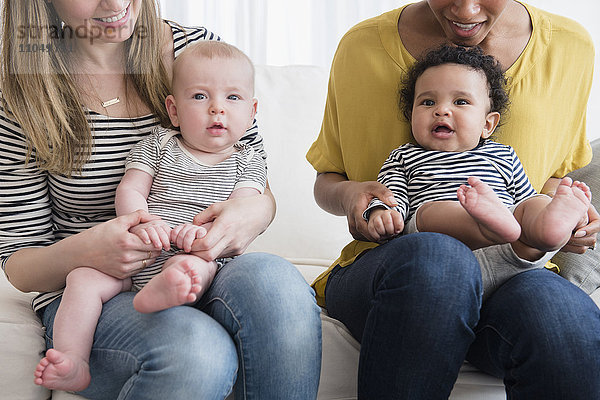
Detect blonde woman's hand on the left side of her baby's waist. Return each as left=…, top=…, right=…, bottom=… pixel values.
left=77, top=210, right=160, bottom=279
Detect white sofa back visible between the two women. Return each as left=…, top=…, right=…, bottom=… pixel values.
left=249, top=66, right=352, bottom=266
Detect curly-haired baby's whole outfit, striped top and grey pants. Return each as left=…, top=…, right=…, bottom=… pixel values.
left=363, top=139, right=558, bottom=300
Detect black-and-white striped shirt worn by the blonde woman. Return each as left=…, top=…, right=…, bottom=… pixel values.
left=0, top=23, right=266, bottom=310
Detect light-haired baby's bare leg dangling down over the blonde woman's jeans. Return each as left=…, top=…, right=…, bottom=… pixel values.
left=34, top=267, right=131, bottom=391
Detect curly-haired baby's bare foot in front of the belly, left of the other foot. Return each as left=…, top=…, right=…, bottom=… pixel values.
left=456, top=176, right=521, bottom=244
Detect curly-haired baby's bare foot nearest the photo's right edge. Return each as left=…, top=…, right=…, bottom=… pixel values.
left=536, top=178, right=592, bottom=251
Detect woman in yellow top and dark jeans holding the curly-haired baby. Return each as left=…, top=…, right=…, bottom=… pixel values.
left=307, top=0, right=600, bottom=399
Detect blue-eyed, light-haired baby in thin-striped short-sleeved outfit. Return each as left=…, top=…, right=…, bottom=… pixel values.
left=34, top=41, right=267, bottom=391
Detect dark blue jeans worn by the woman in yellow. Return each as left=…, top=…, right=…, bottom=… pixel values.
left=325, top=233, right=600, bottom=400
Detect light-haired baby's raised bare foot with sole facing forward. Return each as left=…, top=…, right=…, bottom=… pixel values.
left=133, top=254, right=217, bottom=313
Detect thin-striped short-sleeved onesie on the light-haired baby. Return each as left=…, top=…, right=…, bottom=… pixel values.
left=125, top=128, right=267, bottom=289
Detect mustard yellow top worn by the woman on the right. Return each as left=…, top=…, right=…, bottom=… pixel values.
left=306, top=5, right=594, bottom=306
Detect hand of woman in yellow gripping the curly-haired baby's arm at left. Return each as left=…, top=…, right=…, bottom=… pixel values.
left=314, top=172, right=398, bottom=242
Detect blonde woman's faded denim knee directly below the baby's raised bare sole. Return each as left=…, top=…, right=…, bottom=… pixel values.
left=77, top=292, right=238, bottom=399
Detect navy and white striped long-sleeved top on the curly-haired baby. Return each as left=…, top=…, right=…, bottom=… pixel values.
left=364, top=140, right=536, bottom=221
